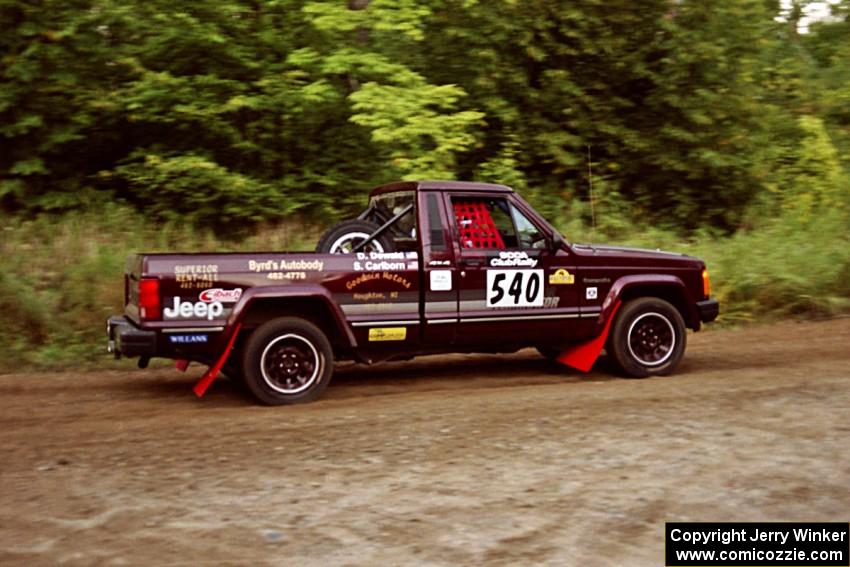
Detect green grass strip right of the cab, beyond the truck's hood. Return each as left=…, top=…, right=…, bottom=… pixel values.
left=565, top=206, right=850, bottom=325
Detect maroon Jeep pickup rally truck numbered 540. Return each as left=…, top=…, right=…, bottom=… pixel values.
left=107, top=181, right=719, bottom=404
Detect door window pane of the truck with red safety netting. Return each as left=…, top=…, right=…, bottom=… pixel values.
left=452, top=197, right=519, bottom=250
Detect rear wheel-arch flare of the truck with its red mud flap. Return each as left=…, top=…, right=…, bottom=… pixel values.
left=190, top=285, right=357, bottom=398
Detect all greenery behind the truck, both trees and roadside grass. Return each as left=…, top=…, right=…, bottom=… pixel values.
left=0, top=0, right=850, bottom=371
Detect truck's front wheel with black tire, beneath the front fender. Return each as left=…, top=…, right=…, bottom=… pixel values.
left=608, top=297, right=687, bottom=378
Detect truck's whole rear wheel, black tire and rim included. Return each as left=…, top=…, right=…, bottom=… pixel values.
left=242, top=317, right=333, bottom=406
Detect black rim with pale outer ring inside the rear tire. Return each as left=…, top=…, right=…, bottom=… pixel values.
left=260, top=333, right=322, bottom=395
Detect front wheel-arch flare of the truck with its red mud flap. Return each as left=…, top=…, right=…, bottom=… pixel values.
left=558, top=274, right=700, bottom=372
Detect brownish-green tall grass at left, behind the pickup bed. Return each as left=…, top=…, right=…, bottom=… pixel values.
left=0, top=205, right=318, bottom=372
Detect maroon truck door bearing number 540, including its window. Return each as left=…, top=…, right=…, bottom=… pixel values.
left=445, top=193, right=579, bottom=347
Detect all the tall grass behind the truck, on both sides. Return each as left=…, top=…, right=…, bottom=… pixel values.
left=0, top=205, right=850, bottom=372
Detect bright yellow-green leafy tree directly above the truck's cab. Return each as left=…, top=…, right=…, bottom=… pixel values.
left=290, top=0, right=483, bottom=179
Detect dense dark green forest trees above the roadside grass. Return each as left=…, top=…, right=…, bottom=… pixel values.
left=0, top=0, right=850, bottom=230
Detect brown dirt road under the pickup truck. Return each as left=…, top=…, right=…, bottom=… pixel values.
left=0, top=319, right=850, bottom=566
